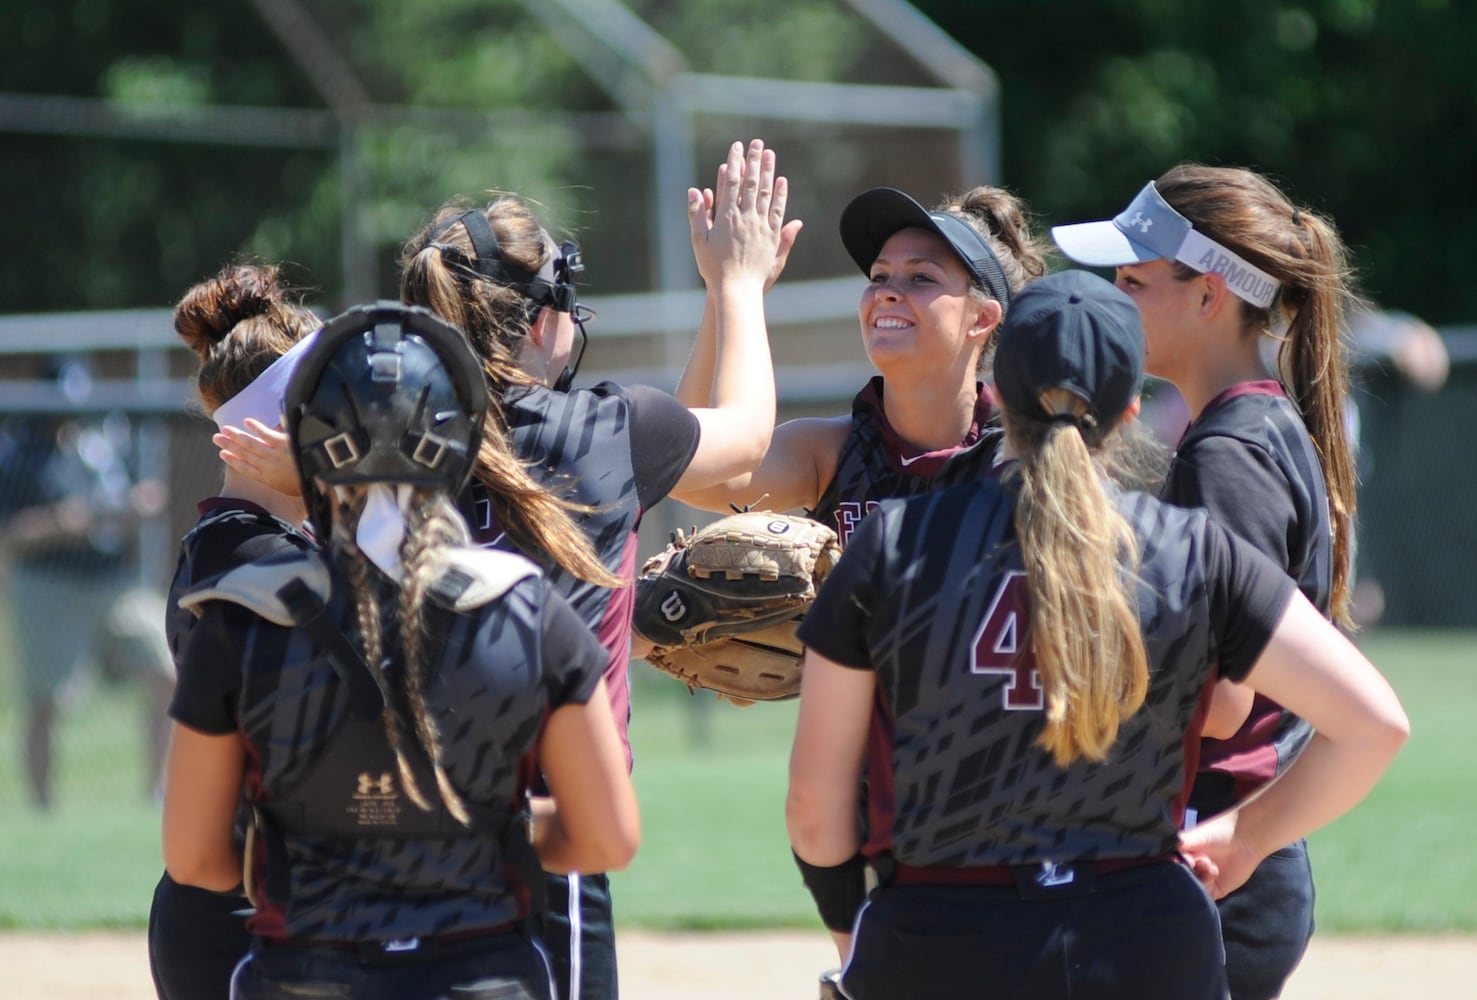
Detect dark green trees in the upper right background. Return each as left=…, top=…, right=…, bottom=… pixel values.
left=917, top=0, right=1477, bottom=322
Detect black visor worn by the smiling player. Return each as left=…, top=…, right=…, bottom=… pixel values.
left=840, top=188, right=1010, bottom=306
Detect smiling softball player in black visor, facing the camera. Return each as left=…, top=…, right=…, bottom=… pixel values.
left=678, top=188, right=1046, bottom=534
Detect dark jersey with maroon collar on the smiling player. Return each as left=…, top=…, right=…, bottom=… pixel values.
left=806, top=375, right=1001, bottom=547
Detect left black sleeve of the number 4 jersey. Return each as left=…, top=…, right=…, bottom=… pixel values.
left=796, top=510, right=885, bottom=671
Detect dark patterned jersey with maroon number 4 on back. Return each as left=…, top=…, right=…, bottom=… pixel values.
left=801, top=479, right=1292, bottom=867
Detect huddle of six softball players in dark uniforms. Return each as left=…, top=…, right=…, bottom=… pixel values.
left=149, top=140, right=1408, bottom=1000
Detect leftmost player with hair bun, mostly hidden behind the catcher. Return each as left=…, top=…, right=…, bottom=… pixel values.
left=149, top=264, right=319, bottom=1000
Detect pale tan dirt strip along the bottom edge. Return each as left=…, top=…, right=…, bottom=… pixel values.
left=0, top=931, right=1477, bottom=1000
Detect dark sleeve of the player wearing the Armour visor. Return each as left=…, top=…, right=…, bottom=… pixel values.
left=1164, top=436, right=1298, bottom=572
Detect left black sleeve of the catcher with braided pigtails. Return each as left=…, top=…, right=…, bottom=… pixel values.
left=170, top=601, right=260, bottom=736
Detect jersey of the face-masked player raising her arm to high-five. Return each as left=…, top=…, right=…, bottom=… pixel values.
left=467, top=383, right=699, bottom=765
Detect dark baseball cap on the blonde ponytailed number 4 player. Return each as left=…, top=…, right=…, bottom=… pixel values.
left=995, top=270, right=1143, bottom=424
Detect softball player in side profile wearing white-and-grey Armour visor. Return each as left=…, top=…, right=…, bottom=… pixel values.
left=1052, top=165, right=1356, bottom=1000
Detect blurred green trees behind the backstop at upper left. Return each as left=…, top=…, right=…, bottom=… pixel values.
left=0, top=0, right=857, bottom=312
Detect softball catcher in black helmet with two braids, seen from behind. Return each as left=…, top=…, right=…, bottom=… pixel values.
left=164, top=303, right=638, bottom=1000
